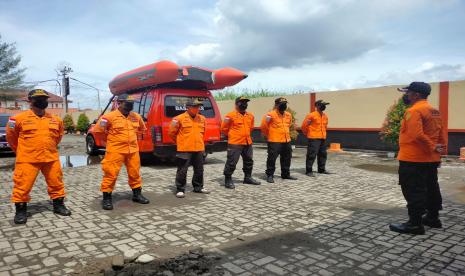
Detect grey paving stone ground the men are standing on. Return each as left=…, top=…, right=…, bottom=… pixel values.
left=0, top=136, right=465, bottom=276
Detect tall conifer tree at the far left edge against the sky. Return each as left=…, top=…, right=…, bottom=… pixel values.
left=0, top=35, right=26, bottom=89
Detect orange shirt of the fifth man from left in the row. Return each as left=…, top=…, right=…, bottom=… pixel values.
left=260, top=109, right=292, bottom=143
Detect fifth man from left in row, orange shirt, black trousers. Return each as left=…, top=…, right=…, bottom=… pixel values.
left=261, top=97, right=297, bottom=183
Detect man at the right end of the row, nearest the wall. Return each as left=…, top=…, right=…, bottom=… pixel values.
left=301, top=100, right=329, bottom=177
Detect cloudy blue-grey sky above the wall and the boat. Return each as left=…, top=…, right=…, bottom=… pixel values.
left=0, top=0, right=465, bottom=108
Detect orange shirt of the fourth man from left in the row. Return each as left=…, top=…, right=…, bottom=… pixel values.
left=221, top=110, right=254, bottom=145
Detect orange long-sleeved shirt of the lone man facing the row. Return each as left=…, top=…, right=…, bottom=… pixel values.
left=397, top=100, right=447, bottom=162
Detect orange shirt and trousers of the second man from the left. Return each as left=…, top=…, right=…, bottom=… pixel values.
left=94, top=109, right=147, bottom=192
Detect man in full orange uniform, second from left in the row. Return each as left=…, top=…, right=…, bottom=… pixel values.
left=95, top=94, right=149, bottom=210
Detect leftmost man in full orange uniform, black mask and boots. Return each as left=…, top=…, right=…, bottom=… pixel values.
left=6, top=89, right=71, bottom=224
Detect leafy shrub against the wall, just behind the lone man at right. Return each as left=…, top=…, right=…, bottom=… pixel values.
left=379, top=98, right=407, bottom=146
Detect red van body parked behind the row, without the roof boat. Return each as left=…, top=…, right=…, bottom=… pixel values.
left=86, top=87, right=227, bottom=160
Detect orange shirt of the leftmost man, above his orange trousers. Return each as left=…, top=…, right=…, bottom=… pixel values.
left=6, top=110, right=64, bottom=163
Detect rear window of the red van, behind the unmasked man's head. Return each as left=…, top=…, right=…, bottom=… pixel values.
left=165, top=95, right=215, bottom=118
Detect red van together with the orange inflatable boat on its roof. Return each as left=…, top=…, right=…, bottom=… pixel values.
left=86, top=60, right=247, bottom=159
